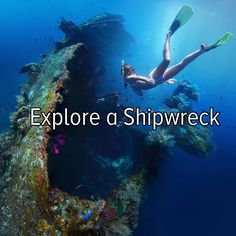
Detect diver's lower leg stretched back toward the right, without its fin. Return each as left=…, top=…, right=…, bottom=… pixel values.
left=163, top=45, right=207, bottom=80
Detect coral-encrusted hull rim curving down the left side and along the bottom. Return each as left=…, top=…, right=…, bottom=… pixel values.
left=0, top=13, right=135, bottom=235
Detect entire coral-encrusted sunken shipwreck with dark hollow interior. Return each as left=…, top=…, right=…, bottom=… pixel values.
left=0, top=14, right=213, bottom=236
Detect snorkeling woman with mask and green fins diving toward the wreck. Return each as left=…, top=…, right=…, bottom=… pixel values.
left=121, top=6, right=233, bottom=95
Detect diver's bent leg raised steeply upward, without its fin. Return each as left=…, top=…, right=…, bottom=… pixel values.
left=148, top=33, right=171, bottom=80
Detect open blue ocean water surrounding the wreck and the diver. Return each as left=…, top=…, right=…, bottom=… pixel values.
left=0, top=0, right=236, bottom=236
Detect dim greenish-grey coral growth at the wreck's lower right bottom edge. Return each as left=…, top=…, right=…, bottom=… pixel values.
left=99, top=172, right=145, bottom=236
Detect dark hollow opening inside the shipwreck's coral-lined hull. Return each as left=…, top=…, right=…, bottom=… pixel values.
left=48, top=46, right=137, bottom=199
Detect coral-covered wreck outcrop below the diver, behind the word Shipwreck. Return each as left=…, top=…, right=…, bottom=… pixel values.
left=146, top=80, right=214, bottom=157
